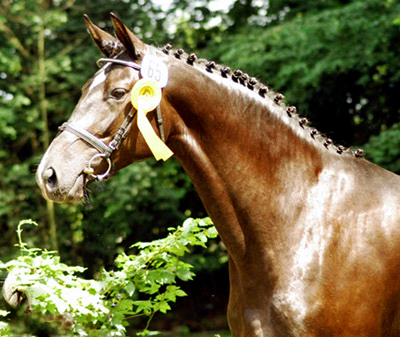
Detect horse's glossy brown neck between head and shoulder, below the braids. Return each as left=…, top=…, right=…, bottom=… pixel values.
left=166, top=63, right=321, bottom=262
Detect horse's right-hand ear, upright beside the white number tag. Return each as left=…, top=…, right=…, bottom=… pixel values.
left=110, top=13, right=146, bottom=60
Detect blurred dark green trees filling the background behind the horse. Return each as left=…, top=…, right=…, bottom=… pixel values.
left=0, top=0, right=400, bottom=334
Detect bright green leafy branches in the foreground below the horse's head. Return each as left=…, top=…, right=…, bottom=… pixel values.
left=0, top=218, right=217, bottom=336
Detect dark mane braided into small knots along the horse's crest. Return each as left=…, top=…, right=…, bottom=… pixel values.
left=161, top=44, right=364, bottom=158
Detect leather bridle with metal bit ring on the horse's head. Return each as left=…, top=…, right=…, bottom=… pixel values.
left=59, top=58, right=165, bottom=181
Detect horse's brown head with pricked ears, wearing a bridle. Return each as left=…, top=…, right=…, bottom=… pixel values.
left=36, top=14, right=170, bottom=202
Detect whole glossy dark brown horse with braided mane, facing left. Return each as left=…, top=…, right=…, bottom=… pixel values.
left=37, top=14, right=400, bottom=337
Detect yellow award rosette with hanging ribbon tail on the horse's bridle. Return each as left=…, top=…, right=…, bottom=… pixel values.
left=131, top=78, right=174, bottom=161
